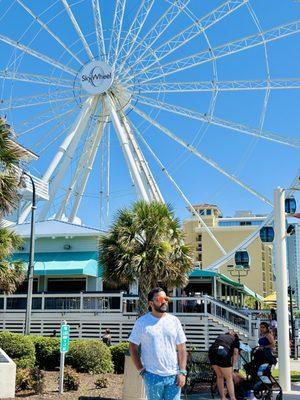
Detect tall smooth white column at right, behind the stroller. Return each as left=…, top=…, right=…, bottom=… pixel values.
left=274, top=188, right=291, bottom=392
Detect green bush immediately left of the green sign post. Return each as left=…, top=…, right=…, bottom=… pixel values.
left=31, top=336, right=60, bottom=371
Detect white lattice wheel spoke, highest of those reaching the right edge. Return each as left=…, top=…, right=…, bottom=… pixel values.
left=133, top=20, right=300, bottom=82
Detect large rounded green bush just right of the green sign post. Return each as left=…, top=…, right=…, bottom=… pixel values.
left=66, top=339, right=114, bottom=374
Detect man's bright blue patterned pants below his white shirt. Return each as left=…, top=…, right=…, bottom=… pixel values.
left=143, top=372, right=181, bottom=400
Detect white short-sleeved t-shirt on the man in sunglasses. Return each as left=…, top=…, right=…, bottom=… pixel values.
left=129, top=312, right=186, bottom=376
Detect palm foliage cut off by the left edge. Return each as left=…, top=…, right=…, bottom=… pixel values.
left=0, top=118, right=27, bottom=293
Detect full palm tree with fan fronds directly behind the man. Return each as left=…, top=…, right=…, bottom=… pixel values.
left=99, top=201, right=192, bottom=315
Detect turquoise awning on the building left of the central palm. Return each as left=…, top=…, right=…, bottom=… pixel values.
left=13, top=251, right=103, bottom=277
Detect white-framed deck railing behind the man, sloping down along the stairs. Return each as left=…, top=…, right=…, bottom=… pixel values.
left=0, top=292, right=259, bottom=336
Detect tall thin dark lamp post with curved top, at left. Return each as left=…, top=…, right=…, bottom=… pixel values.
left=23, top=171, right=36, bottom=335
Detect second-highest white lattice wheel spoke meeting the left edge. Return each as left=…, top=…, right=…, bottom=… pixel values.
left=0, top=69, right=76, bottom=89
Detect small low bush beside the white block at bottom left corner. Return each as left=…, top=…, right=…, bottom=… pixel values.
left=16, top=367, right=45, bottom=394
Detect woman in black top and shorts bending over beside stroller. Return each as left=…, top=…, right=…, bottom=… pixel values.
left=208, top=331, right=240, bottom=400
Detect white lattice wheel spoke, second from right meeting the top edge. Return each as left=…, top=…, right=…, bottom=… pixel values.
left=118, top=0, right=191, bottom=77
